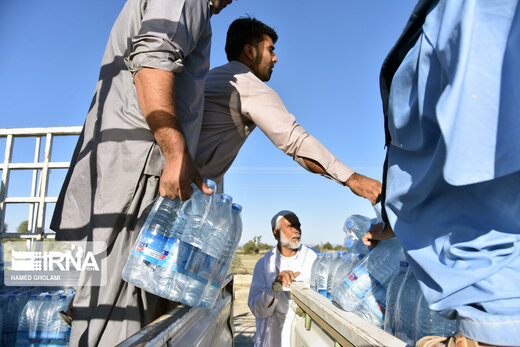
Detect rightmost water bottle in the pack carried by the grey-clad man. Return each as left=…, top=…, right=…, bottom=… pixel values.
left=180, top=194, right=233, bottom=306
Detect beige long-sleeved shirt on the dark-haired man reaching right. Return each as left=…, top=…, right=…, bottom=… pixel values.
left=195, top=61, right=354, bottom=183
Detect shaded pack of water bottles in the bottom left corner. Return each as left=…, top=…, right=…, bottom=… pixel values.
left=0, top=287, right=75, bottom=346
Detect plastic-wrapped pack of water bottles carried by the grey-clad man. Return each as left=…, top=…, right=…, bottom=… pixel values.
left=122, top=180, right=242, bottom=308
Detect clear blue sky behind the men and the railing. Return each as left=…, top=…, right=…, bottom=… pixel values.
left=0, top=0, right=416, bottom=244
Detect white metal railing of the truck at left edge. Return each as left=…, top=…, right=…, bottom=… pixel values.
left=0, top=126, right=82, bottom=237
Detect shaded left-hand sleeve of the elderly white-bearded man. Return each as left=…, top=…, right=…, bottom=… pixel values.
left=247, top=258, right=280, bottom=318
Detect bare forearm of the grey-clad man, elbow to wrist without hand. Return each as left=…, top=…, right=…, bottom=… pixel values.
left=135, top=68, right=186, bottom=160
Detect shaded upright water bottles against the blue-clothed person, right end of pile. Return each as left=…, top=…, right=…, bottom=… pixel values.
left=384, top=261, right=455, bottom=345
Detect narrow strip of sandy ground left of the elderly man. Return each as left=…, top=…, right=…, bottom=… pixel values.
left=233, top=254, right=263, bottom=347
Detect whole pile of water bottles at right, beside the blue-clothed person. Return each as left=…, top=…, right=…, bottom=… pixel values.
left=311, top=210, right=455, bottom=345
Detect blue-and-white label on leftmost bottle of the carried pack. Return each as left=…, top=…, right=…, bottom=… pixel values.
left=132, top=229, right=172, bottom=266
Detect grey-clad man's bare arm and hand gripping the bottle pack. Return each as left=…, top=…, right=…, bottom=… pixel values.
left=134, top=68, right=212, bottom=200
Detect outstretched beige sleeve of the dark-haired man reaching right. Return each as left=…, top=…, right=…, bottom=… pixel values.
left=241, top=80, right=354, bottom=183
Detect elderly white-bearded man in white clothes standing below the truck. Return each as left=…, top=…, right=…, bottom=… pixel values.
left=248, top=210, right=317, bottom=347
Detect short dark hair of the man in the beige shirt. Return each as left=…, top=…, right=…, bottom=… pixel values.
left=226, top=17, right=278, bottom=61
